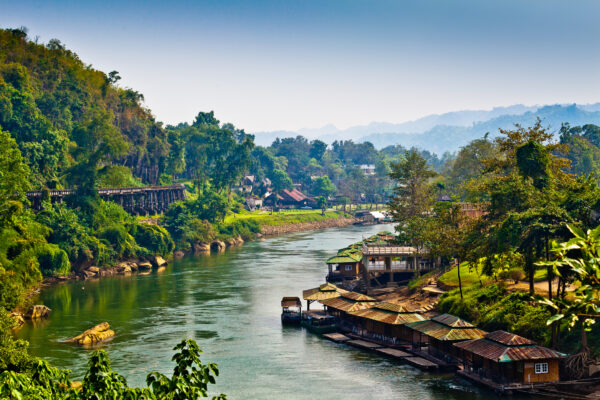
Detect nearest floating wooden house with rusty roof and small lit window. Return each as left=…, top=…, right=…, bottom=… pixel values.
left=454, top=331, right=564, bottom=385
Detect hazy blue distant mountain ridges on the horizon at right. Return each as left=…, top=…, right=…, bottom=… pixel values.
left=254, top=103, right=600, bottom=154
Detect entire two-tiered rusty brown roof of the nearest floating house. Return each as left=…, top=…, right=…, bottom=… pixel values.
left=454, top=331, right=564, bottom=362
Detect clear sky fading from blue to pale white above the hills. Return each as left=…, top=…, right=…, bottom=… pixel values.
left=0, top=0, right=600, bottom=132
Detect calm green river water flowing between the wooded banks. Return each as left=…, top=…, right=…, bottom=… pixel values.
left=18, top=225, right=502, bottom=400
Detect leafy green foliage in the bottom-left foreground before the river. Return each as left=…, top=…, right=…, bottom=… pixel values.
left=0, top=339, right=226, bottom=400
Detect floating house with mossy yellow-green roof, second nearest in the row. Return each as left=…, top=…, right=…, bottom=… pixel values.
left=404, top=314, right=486, bottom=361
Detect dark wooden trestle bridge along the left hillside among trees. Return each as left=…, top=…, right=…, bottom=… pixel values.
left=26, top=185, right=185, bottom=215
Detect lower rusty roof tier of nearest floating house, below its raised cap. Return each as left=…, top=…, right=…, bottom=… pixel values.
left=454, top=338, right=564, bottom=362
